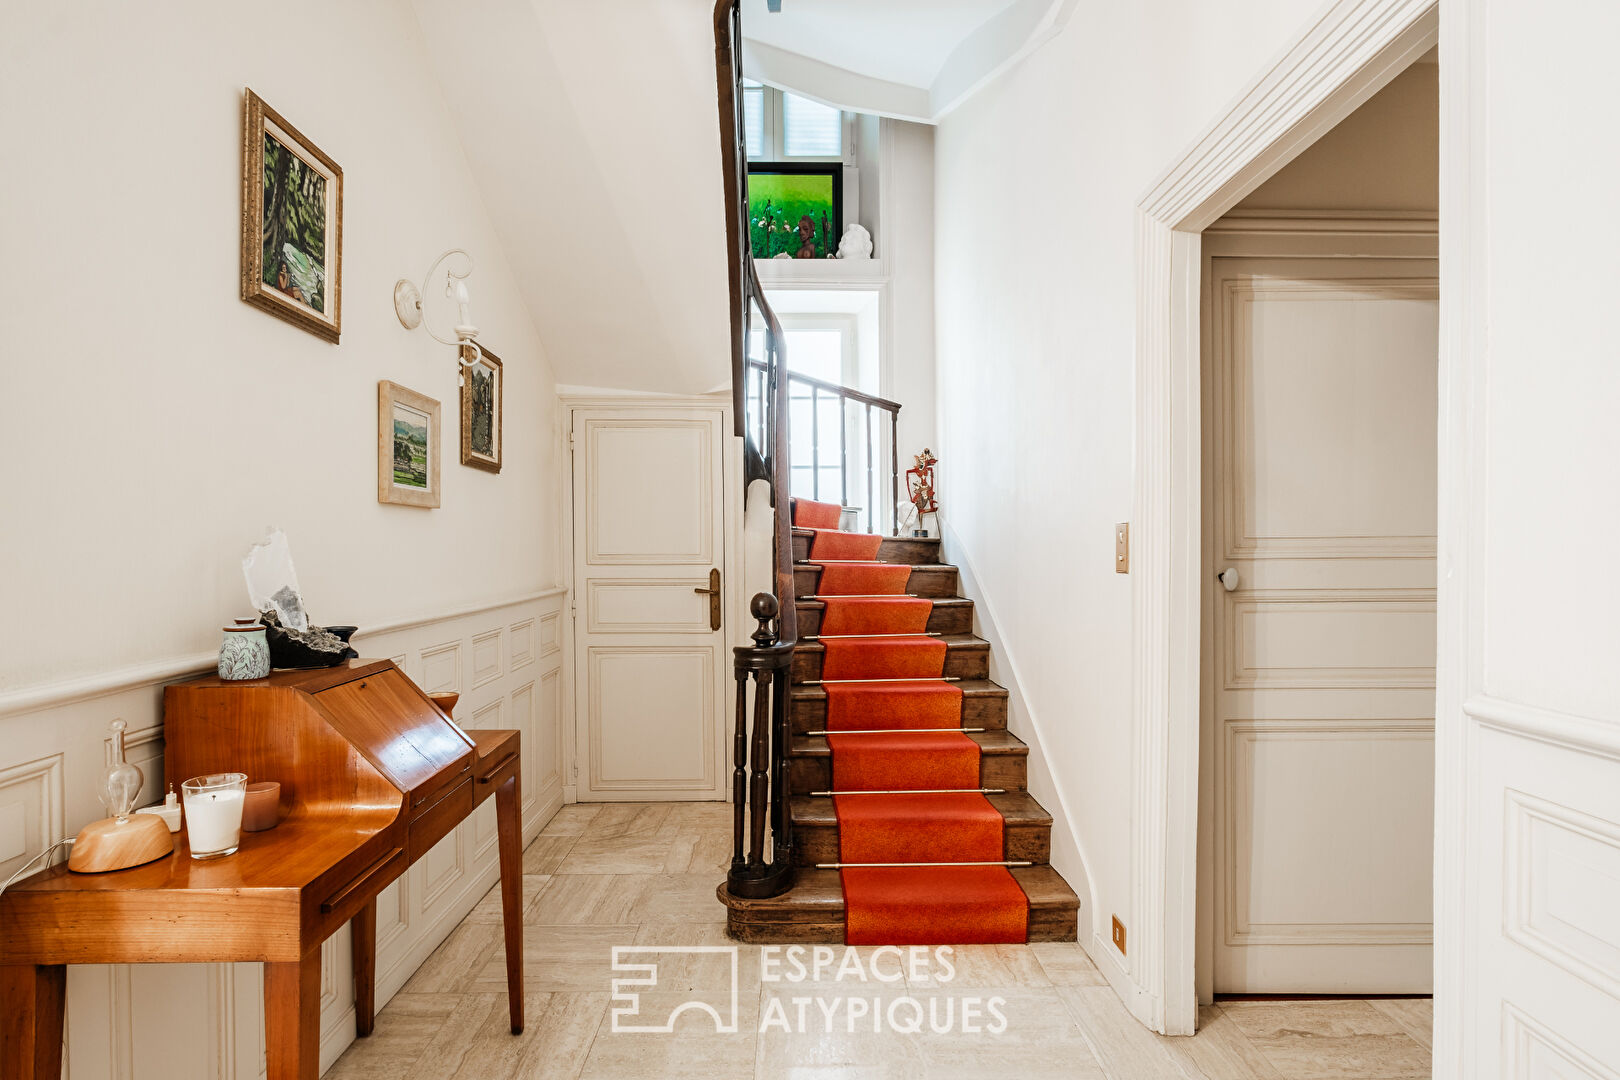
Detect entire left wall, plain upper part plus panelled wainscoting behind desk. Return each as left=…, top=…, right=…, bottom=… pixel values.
left=0, top=0, right=565, bottom=1080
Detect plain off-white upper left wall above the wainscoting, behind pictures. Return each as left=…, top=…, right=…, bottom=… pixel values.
left=0, top=0, right=557, bottom=690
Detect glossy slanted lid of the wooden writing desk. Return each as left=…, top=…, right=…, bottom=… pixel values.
left=314, top=667, right=473, bottom=806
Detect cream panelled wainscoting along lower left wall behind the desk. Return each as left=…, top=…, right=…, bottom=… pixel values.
left=0, top=589, right=567, bottom=1080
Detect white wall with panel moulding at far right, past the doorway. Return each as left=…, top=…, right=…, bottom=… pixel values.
left=1434, top=0, right=1620, bottom=1080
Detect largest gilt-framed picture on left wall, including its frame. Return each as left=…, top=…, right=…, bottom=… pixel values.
left=241, top=89, right=343, bottom=345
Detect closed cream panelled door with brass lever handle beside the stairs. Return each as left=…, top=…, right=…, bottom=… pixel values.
left=572, top=408, right=731, bottom=801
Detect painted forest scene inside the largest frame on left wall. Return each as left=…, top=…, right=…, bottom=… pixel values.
left=261, top=131, right=327, bottom=314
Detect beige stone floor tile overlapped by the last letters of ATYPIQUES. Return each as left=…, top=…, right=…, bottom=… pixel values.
left=910, top=986, right=1114, bottom=1080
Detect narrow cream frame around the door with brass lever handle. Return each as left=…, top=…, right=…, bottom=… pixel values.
left=557, top=390, right=755, bottom=803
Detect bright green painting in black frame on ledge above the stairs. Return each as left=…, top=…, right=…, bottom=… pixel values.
left=748, top=162, right=844, bottom=259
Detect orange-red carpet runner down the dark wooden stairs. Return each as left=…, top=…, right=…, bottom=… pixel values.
left=794, top=499, right=1029, bottom=946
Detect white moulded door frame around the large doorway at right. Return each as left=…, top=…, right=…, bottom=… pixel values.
left=1127, top=0, right=1461, bottom=1036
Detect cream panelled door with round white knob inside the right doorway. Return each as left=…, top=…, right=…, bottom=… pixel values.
left=1205, top=257, right=1439, bottom=993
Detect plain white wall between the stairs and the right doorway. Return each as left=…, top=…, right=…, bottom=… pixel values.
left=935, top=0, right=1334, bottom=988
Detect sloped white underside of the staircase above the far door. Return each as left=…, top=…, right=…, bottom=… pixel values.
left=413, top=0, right=731, bottom=393
